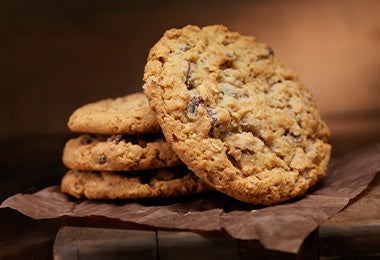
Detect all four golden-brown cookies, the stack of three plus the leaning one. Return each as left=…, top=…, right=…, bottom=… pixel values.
left=62, top=25, right=331, bottom=205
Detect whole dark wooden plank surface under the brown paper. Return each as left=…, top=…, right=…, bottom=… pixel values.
left=48, top=175, right=380, bottom=260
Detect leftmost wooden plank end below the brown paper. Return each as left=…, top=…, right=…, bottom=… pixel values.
left=53, top=218, right=157, bottom=260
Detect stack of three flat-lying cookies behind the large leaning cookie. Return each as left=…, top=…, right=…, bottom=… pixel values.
left=61, top=93, right=210, bottom=199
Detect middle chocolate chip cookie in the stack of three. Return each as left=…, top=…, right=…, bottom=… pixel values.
left=62, top=133, right=183, bottom=171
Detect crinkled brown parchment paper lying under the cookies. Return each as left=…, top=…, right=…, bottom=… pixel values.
left=0, top=143, right=380, bottom=253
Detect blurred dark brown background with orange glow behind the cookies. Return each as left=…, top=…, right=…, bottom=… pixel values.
left=0, top=0, right=380, bottom=259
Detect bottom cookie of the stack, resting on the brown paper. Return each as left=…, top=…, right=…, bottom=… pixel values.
left=61, top=168, right=211, bottom=199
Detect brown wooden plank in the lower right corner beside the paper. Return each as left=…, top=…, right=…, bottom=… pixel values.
left=319, top=174, right=380, bottom=259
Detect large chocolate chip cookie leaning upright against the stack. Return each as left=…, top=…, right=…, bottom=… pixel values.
left=143, top=25, right=331, bottom=205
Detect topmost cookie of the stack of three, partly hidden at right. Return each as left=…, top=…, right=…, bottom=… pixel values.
left=67, top=92, right=161, bottom=134
